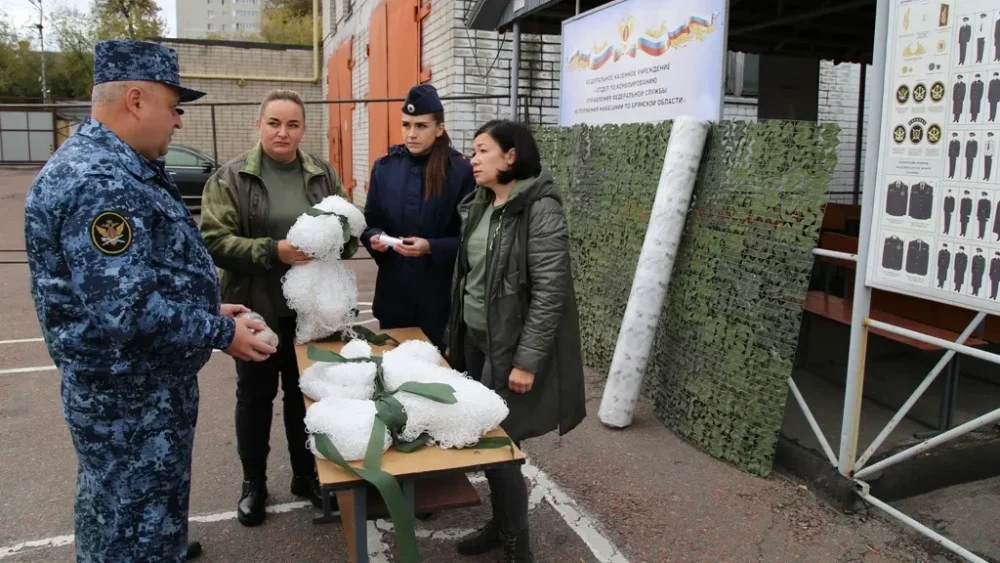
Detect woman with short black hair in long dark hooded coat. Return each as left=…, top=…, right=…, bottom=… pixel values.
left=446, top=121, right=586, bottom=563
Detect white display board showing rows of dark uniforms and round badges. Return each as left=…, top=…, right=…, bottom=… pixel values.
left=866, top=0, right=1000, bottom=313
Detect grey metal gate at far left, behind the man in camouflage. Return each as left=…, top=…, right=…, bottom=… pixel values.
left=0, top=106, right=56, bottom=164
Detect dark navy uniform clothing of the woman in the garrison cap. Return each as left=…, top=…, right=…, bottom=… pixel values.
left=361, top=145, right=476, bottom=347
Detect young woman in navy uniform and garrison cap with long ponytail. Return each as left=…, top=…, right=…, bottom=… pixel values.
left=361, top=84, right=475, bottom=350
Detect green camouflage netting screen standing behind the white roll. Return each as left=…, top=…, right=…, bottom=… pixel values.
left=538, top=121, right=839, bottom=475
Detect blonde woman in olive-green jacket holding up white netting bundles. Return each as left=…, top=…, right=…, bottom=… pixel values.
left=201, top=90, right=358, bottom=526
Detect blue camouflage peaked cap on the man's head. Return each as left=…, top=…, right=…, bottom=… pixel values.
left=94, top=39, right=205, bottom=102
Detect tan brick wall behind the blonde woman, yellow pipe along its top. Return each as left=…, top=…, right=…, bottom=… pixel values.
left=159, top=39, right=326, bottom=162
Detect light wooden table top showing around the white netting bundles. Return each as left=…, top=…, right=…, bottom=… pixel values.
left=295, top=328, right=524, bottom=489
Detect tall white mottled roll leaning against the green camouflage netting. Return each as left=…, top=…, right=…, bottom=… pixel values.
left=598, top=116, right=710, bottom=428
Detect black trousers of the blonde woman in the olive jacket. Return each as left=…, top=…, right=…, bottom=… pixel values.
left=236, top=318, right=316, bottom=481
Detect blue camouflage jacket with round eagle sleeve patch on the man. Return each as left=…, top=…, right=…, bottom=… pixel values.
left=24, top=118, right=235, bottom=376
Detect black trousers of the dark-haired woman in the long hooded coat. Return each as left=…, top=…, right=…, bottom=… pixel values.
left=465, top=329, right=528, bottom=533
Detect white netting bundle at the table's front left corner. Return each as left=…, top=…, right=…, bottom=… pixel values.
left=305, top=397, right=392, bottom=461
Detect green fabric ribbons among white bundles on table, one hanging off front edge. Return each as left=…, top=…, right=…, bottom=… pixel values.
left=306, top=344, right=514, bottom=563
